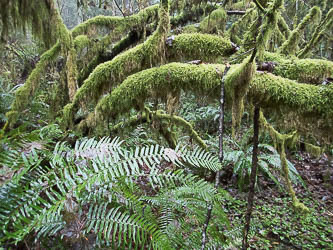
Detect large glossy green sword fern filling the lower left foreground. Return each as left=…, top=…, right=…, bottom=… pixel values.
left=0, top=137, right=228, bottom=249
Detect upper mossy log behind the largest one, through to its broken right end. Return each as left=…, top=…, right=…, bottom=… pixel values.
left=66, top=31, right=235, bottom=127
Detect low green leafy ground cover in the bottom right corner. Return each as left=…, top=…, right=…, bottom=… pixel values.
left=223, top=190, right=333, bottom=249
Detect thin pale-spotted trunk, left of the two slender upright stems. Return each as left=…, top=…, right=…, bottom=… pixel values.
left=201, top=64, right=230, bottom=250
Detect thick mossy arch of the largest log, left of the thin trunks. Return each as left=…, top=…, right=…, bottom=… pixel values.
left=89, top=63, right=223, bottom=125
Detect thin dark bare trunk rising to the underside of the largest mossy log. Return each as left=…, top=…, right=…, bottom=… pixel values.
left=242, top=106, right=260, bottom=250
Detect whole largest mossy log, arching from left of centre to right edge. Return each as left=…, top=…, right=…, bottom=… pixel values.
left=82, top=63, right=333, bottom=130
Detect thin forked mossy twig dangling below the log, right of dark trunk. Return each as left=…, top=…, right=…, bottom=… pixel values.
left=259, top=112, right=309, bottom=213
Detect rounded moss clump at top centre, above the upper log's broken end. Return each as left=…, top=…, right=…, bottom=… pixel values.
left=200, top=8, right=227, bottom=33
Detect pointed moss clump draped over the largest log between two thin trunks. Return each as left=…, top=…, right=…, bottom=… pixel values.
left=226, top=57, right=256, bottom=137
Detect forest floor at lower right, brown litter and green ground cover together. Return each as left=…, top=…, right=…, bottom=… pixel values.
left=220, top=153, right=333, bottom=249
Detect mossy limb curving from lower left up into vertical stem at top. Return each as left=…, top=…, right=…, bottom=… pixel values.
left=64, top=1, right=170, bottom=124
